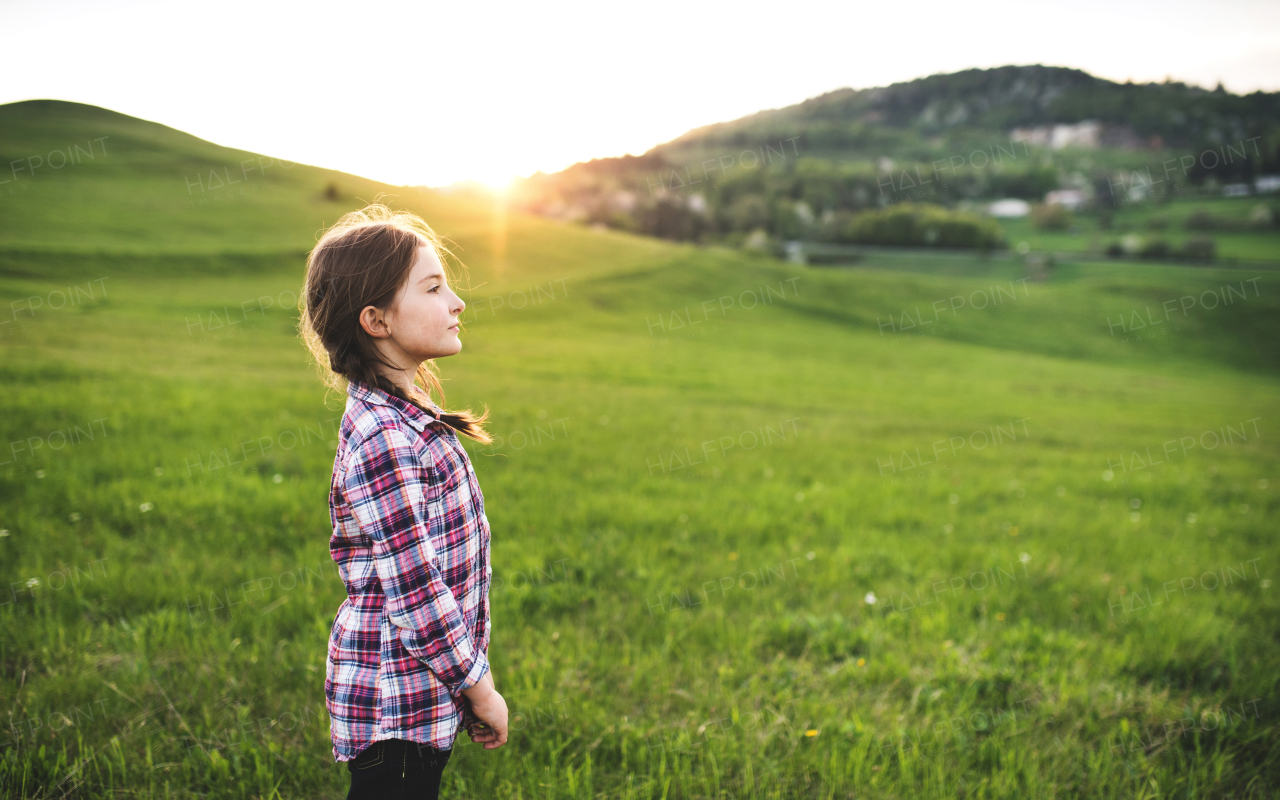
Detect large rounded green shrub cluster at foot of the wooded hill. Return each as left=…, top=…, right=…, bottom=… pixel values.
left=844, top=202, right=1002, bottom=250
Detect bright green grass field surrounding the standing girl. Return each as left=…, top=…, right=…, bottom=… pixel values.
left=0, top=104, right=1280, bottom=800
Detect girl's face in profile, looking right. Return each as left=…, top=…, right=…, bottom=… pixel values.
left=385, top=247, right=467, bottom=364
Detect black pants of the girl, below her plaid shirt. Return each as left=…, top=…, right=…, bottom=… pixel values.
left=347, top=739, right=453, bottom=800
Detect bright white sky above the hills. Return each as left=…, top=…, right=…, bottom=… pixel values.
left=0, top=0, right=1280, bottom=186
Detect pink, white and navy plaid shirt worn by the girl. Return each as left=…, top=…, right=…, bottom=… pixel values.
left=325, top=381, right=493, bottom=762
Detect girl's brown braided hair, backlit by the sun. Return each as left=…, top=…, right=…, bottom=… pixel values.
left=300, top=204, right=493, bottom=444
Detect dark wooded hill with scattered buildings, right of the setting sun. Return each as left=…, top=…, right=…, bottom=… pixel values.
left=512, top=65, right=1280, bottom=253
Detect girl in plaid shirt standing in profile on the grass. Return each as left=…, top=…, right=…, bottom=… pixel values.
left=302, top=205, right=507, bottom=800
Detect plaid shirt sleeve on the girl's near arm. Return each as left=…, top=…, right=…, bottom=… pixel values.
left=343, top=429, right=489, bottom=695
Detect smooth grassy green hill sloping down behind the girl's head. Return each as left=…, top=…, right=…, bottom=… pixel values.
left=0, top=100, right=680, bottom=285
